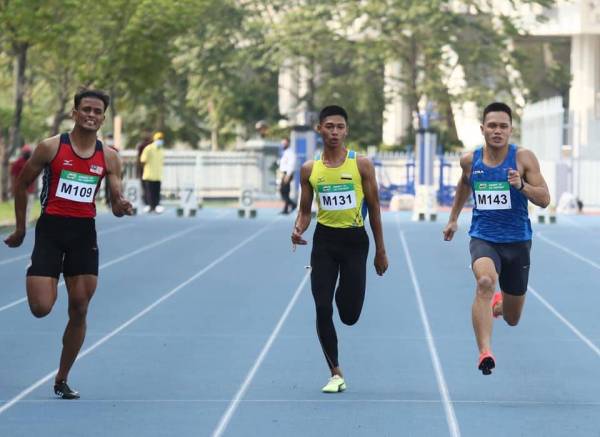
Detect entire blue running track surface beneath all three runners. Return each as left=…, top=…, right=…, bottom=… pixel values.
left=0, top=210, right=600, bottom=437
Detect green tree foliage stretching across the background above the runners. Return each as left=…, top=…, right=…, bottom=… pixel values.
left=0, top=0, right=569, bottom=159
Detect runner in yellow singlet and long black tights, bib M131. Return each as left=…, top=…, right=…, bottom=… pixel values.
left=292, top=106, right=388, bottom=393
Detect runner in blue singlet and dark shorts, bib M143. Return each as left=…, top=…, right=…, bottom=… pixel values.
left=443, top=102, right=550, bottom=375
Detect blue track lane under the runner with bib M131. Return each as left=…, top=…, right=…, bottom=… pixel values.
left=225, top=215, right=448, bottom=436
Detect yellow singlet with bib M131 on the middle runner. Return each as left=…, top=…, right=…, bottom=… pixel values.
left=308, top=150, right=367, bottom=228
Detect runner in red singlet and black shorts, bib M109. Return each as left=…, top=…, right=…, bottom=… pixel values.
left=4, top=89, right=133, bottom=399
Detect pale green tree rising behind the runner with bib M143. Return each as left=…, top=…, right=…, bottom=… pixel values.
left=347, top=0, right=553, bottom=149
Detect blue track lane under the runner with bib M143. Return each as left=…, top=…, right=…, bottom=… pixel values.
left=398, top=215, right=600, bottom=436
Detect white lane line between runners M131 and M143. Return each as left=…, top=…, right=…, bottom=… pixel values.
left=397, top=227, right=460, bottom=437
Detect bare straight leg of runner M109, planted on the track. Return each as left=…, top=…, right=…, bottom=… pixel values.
left=56, top=275, right=98, bottom=382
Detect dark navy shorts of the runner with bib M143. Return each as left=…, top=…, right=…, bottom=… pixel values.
left=469, top=238, right=531, bottom=296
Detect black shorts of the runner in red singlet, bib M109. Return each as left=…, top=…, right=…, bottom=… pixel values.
left=27, top=214, right=98, bottom=278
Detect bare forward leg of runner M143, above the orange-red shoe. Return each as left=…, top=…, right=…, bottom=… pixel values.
left=471, top=257, right=498, bottom=353
